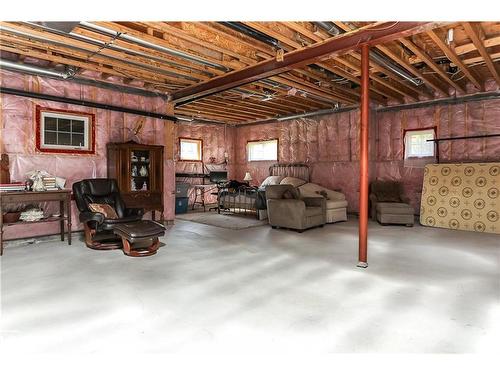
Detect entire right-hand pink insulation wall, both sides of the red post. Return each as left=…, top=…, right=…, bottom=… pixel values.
left=235, top=100, right=500, bottom=212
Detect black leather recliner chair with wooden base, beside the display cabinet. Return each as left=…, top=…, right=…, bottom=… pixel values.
left=73, top=178, right=144, bottom=250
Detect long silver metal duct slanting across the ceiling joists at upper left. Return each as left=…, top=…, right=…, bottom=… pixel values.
left=80, top=21, right=229, bottom=71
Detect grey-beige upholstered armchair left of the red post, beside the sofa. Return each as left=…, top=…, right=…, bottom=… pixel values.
left=266, top=185, right=326, bottom=232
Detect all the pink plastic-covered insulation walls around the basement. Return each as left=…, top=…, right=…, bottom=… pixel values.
left=0, top=71, right=500, bottom=242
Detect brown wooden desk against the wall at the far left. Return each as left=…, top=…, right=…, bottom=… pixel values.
left=0, top=190, right=71, bottom=255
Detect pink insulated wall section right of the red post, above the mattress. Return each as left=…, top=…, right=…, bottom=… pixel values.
left=372, top=100, right=500, bottom=212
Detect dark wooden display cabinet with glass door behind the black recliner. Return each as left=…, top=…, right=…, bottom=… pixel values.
left=107, top=141, right=164, bottom=221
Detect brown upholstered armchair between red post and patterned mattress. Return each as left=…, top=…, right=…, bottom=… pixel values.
left=370, top=180, right=415, bottom=227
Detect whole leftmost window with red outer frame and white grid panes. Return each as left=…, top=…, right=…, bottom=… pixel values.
left=36, top=107, right=95, bottom=154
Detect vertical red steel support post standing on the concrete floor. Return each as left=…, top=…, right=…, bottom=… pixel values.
left=358, top=44, right=370, bottom=268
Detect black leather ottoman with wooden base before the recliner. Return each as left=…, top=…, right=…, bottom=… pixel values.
left=113, top=220, right=165, bottom=257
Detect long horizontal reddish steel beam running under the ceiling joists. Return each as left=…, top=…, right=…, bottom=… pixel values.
left=172, top=22, right=433, bottom=103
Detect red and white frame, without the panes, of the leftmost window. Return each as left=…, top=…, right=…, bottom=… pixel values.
left=35, top=105, right=95, bottom=155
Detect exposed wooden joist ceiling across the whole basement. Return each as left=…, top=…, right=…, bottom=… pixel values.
left=0, top=21, right=500, bottom=124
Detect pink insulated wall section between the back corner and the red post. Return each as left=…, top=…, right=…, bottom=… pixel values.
left=235, top=110, right=374, bottom=210
